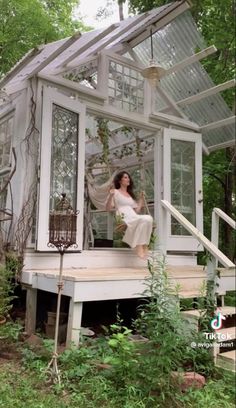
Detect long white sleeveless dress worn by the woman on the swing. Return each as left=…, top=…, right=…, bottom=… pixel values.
left=114, top=190, right=153, bottom=248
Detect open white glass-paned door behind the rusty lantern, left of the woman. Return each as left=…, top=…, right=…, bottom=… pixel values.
left=37, top=87, right=85, bottom=251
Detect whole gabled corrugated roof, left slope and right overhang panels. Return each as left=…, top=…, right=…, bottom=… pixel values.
left=0, top=1, right=234, bottom=150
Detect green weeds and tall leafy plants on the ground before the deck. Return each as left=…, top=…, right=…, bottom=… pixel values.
left=0, top=256, right=235, bottom=408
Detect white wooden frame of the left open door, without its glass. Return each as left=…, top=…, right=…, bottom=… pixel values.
left=36, top=87, right=85, bottom=251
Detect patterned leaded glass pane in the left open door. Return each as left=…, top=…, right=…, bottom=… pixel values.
left=50, top=104, right=79, bottom=209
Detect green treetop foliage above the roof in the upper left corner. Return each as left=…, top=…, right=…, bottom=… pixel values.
left=0, top=0, right=86, bottom=77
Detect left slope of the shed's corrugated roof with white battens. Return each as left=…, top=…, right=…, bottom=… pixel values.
left=0, top=1, right=180, bottom=89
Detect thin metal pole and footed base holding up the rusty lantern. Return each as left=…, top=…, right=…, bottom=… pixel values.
left=45, top=249, right=65, bottom=384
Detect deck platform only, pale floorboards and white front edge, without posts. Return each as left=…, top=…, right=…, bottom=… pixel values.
left=22, top=266, right=206, bottom=302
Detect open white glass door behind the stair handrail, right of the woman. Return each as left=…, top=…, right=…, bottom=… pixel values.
left=163, top=129, right=203, bottom=251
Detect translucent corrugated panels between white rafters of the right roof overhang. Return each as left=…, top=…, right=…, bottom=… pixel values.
left=135, top=11, right=235, bottom=150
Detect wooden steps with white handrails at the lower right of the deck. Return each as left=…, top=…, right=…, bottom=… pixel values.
left=161, top=200, right=236, bottom=372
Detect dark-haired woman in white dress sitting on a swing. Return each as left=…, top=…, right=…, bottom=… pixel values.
left=106, top=171, right=153, bottom=258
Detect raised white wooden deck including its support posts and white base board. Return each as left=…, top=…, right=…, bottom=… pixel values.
left=22, top=250, right=235, bottom=344
